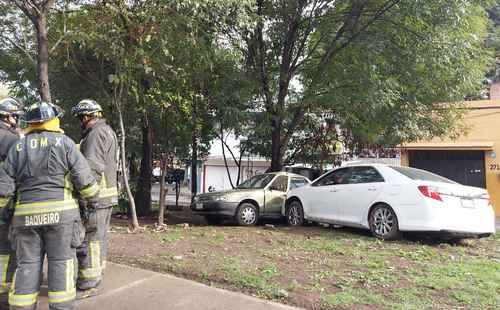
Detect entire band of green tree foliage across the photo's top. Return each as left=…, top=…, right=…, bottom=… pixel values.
left=0, top=0, right=500, bottom=170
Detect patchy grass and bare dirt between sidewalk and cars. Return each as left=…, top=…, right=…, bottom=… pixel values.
left=110, top=220, right=500, bottom=310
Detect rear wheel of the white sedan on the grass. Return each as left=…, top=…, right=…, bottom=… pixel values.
left=369, top=205, right=401, bottom=240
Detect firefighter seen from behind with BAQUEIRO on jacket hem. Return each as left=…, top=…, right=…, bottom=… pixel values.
left=0, top=102, right=99, bottom=310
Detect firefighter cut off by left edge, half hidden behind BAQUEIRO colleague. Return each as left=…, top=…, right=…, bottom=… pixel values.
left=0, top=98, right=21, bottom=309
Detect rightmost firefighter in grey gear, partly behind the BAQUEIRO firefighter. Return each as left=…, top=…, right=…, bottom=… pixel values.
left=71, top=99, right=118, bottom=299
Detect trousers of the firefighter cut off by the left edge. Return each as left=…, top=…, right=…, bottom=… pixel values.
left=0, top=225, right=16, bottom=309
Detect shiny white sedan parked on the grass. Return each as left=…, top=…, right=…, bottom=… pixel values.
left=282, top=164, right=495, bottom=239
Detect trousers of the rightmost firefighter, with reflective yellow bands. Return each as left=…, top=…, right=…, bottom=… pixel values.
left=76, top=207, right=113, bottom=290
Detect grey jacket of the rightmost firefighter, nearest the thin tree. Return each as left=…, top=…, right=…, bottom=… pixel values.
left=80, top=118, right=118, bottom=208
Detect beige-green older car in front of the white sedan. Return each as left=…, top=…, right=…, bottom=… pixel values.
left=191, top=172, right=310, bottom=226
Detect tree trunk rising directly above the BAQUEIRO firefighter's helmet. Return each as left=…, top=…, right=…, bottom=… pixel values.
left=34, top=14, right=51, bottom=102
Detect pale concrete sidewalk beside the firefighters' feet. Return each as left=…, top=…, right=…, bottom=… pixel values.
left=39, top=263, right=298, bottom=310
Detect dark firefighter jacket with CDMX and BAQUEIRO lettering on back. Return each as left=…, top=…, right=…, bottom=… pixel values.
left=0, top=131, right=99, bottom=226
